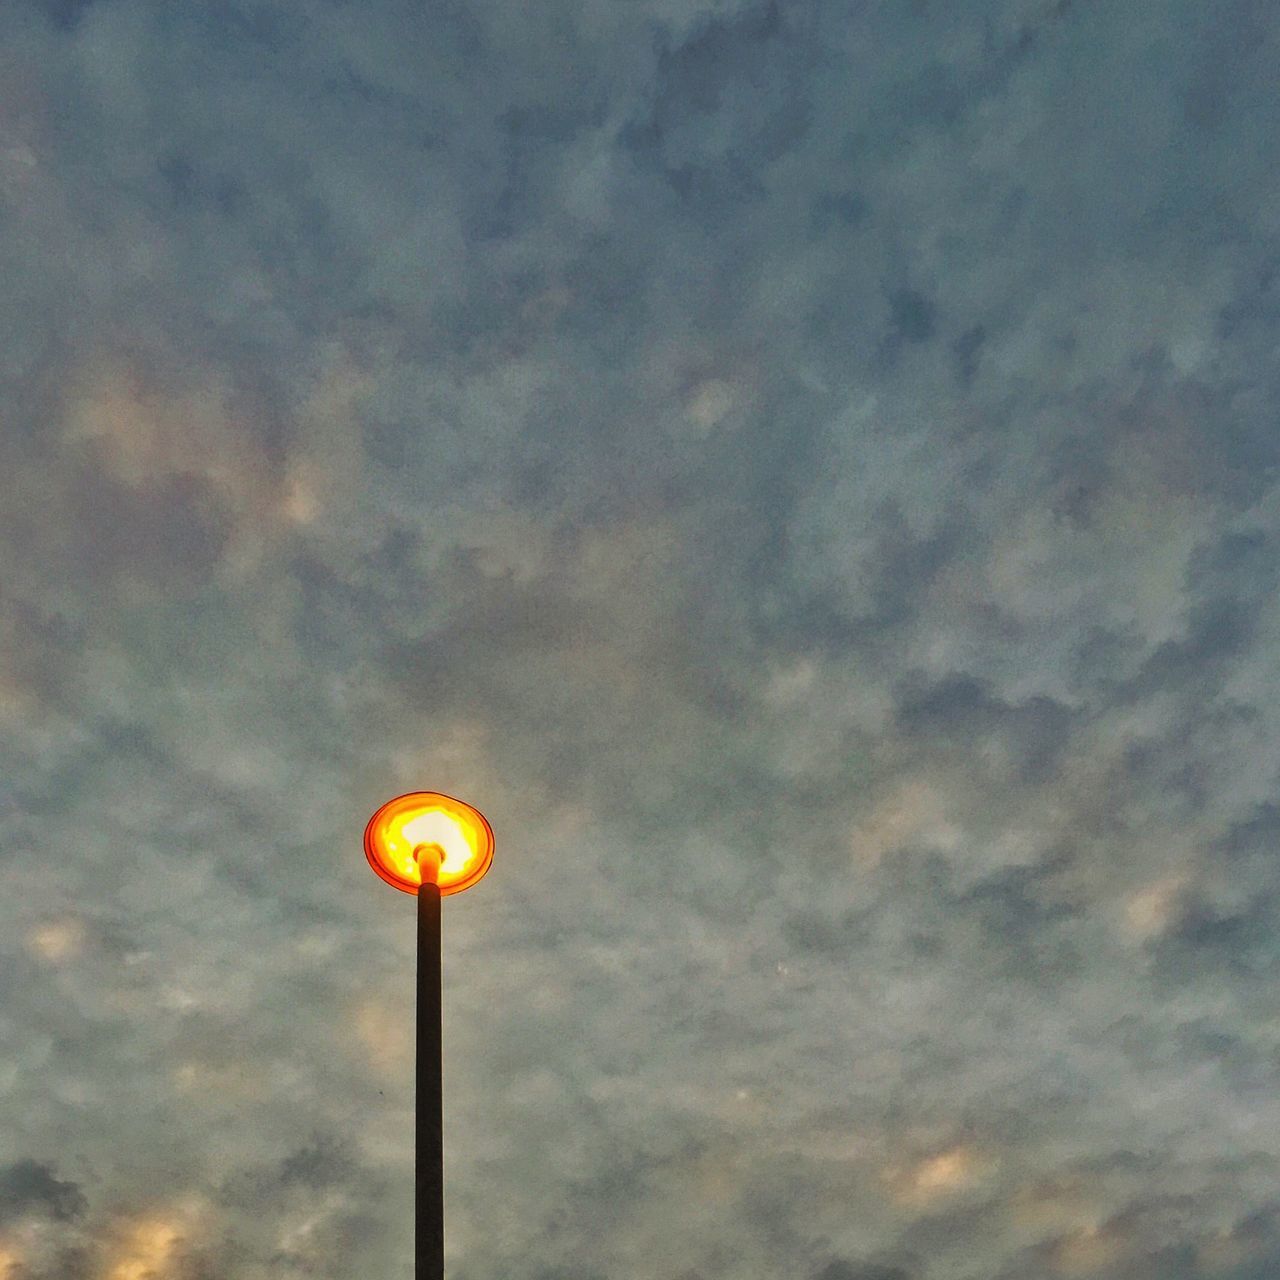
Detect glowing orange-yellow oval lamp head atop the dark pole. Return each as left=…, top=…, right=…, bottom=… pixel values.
left=365, top=791, right=493, bottom=897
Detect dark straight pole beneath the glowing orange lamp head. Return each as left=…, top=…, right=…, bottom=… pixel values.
left=413, top=876, right=444, bottom=1280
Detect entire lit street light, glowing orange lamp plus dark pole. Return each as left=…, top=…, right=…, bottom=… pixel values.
left=365, top=791, right=493, bottom=1280
